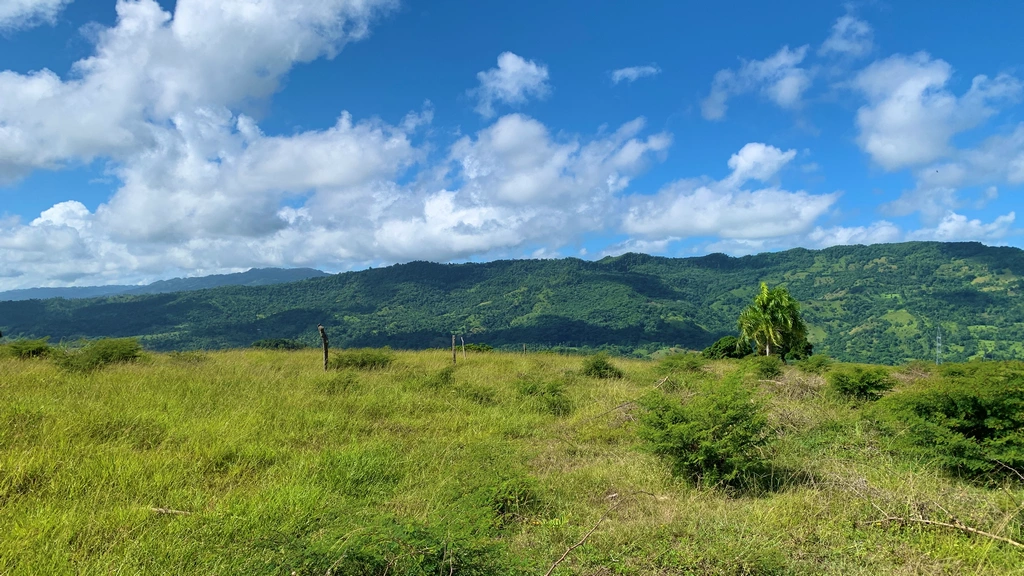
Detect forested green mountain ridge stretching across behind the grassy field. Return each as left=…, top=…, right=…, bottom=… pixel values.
left=0, top=243, right=1024, bottom=364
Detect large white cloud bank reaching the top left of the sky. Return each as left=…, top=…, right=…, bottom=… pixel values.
left=0, top=0, right=394, bottom=181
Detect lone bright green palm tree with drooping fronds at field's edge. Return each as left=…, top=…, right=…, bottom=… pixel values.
left=738, top=282, right=807, bottom=356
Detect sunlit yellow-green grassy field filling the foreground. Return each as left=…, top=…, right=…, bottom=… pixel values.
left=0, top=351, right=1024, bottom=575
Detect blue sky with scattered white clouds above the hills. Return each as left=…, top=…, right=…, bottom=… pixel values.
left=0, top=0, right=1024, bottom=289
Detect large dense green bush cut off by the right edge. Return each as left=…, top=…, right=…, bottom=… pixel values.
left=874, top=362, right=1024, bottom=479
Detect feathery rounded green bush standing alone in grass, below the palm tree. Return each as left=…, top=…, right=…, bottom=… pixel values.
left=640, top=378, right=771, bottom=487
